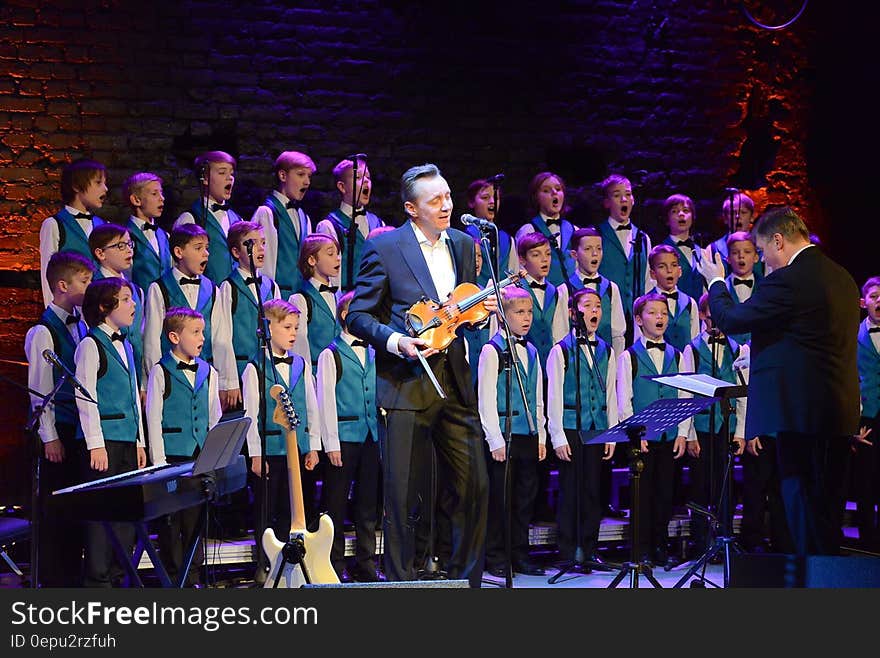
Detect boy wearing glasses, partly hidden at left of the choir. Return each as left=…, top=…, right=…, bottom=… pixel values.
left=89, top=222, right=147, bottom=386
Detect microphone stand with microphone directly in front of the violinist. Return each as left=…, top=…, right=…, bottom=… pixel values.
left=478, top=223, right=538, bottom=589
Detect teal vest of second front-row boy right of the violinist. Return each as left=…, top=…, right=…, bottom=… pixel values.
left=559, top=334, right=611, bottom=430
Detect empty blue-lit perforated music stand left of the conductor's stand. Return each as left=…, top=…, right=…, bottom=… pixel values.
left=585, top=398, right=717, bottom=589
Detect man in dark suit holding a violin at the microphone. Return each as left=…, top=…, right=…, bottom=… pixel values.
left=348, top=164, right=497, bottom=587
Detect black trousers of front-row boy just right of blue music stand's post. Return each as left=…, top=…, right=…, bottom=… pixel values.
left=630, top=440, right=675, bottom=556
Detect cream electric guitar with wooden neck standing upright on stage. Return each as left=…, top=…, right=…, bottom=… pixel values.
left=263, top=384, right=339, bottom=588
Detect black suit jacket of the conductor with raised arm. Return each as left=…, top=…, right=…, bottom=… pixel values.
left=709, top=247, right=859, bottom=438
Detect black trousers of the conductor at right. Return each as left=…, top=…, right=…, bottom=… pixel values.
left=776, top=432, right=849, bottom=555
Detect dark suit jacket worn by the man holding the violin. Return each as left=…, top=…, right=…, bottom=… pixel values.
left=347, top=222, right=477, bottom=410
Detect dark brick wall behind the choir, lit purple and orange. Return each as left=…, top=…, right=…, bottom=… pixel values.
left=0, top=0, right=880, bottom=503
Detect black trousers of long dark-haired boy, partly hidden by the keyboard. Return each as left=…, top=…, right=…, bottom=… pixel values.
left=82, top=441, right=137, bottom=587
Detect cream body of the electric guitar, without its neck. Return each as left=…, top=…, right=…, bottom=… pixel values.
left=262, top=514, right=339, bottom=589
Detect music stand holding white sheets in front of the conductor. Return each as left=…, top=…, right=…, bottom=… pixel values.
left=652, top=374, right=748, bottom=587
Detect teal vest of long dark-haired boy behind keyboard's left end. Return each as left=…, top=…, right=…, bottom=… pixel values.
left=89, top=327, right=140, bottom=443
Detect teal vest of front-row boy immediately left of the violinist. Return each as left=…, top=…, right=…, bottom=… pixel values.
left=327, top=337, right=379, bottom=443
